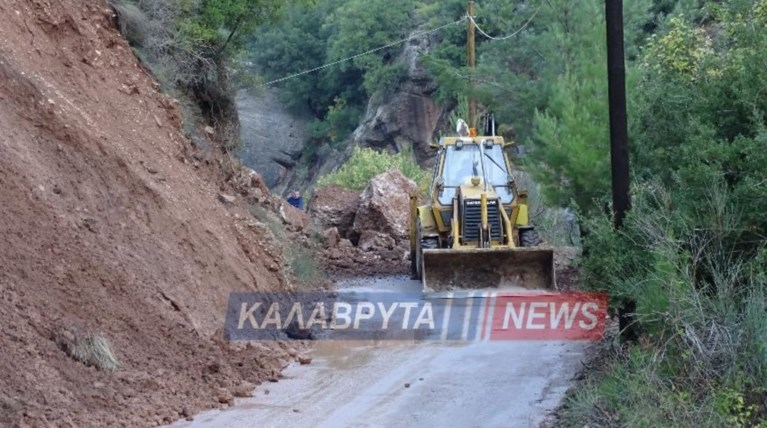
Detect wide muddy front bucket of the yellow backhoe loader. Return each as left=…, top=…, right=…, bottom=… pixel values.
left=422, top=247, right=556, bottom=292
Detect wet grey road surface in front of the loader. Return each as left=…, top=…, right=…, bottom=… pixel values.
left=168, top=279, right=588, bottom=427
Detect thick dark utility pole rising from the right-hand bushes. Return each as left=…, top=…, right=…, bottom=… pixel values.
left=605, top=0, right=631, bottom=229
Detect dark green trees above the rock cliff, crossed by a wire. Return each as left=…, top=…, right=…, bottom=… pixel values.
left=250, top=0, right=416, bottom=144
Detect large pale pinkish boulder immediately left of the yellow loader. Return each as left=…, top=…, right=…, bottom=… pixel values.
left=352, top=169, right=418, bottom=246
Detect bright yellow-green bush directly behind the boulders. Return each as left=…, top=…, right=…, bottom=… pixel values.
left=317, top=147, right=430, bottom=191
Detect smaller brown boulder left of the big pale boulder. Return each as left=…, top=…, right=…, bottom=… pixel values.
left=309, top=186, right=360, bottom=238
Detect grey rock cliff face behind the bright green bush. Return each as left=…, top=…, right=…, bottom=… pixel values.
left=237, top=32, right=446, bottom=194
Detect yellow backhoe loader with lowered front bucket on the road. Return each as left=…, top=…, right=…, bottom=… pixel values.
left=410, top=126, right=555, bottom=292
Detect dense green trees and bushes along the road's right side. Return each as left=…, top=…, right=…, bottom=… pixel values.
left=414, top=0, right=767, bottom=427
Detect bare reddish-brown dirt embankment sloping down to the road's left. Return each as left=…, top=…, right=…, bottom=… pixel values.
left=0, top=0, right=306, bottom=426
